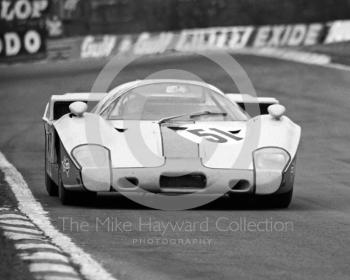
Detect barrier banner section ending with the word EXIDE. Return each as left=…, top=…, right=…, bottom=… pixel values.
left=175, top=23, right=328, bottom=51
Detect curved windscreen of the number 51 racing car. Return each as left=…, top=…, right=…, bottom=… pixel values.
left=102, top=83, right=247, bottom=121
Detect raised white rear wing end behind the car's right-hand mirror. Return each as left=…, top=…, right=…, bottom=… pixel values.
left=226, top=93, right=279, bottom=117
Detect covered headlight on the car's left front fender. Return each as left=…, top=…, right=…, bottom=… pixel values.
left=72, top=144, right=110, bottom=168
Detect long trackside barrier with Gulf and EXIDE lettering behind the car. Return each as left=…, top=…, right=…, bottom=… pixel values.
left=3, top=20, right=350, bottom=61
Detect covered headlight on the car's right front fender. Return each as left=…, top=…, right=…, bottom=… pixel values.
left=253, top=147, right=290, bottom=171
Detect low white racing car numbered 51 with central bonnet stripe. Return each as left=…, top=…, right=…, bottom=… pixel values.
left=43, top=79, right=301, bottom=207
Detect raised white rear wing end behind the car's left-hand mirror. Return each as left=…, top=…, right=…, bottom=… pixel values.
left=43, top=92, right=107, bottom=122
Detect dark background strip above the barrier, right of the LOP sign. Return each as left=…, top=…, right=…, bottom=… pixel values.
left=51, top=0, right=350, bottom=36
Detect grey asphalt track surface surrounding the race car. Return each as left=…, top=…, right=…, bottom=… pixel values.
left=0, top=53, right=350, bottom=280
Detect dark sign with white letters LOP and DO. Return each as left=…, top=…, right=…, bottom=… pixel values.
left=0, top=0, right=48, bottom=61
